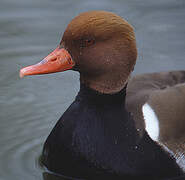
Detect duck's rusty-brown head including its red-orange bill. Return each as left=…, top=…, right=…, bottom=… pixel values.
left=20, top=11, right=137, bottom=93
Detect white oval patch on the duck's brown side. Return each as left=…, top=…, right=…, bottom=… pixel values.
left=142, top=103, right=159, bottom=141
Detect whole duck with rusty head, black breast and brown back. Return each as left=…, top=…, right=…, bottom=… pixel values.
left=20, top=10, right=185, bottom=180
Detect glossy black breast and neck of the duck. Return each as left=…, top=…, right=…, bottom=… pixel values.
left=42, top=85, right=182, bottom=179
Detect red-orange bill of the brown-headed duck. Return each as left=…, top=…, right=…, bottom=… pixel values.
left=20, top=47, right=75, bottom=78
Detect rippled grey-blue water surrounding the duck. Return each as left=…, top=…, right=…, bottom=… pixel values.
left=0, top=0, right=185, bottom=180
